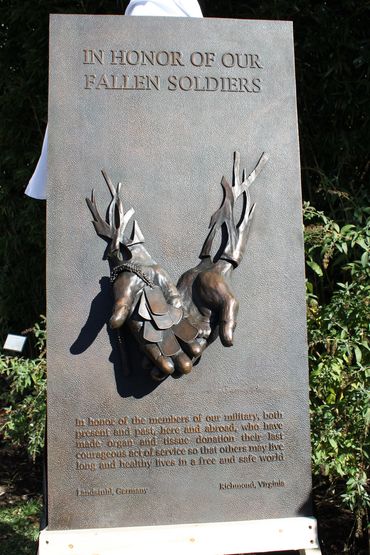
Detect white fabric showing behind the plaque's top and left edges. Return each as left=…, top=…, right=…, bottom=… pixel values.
left=25, top=0, right=203, bottom=199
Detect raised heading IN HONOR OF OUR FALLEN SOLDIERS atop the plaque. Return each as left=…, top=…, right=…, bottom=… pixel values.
left=82, top=48, right=263, bottom=93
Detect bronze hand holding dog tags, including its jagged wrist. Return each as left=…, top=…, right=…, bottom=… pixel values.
left=86, top=172, right=201, bottom=381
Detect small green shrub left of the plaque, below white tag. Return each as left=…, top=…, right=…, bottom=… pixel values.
left=0, top=318, right=46, bottom=460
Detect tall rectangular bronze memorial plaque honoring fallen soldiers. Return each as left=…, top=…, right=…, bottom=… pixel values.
left=44, top=15, right=311, bottom=540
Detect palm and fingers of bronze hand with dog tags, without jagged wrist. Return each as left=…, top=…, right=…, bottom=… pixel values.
left=110, top=245, right=202, bottom=381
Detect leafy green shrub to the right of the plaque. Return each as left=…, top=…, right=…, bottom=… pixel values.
left=304, top=204, right=370, bottom=513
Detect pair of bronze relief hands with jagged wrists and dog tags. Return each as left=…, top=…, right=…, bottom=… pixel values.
left=86, top=152, right=268, bottom=381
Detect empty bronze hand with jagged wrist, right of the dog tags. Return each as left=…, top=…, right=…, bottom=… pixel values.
left=177, top=152, right=268, bottom=358
